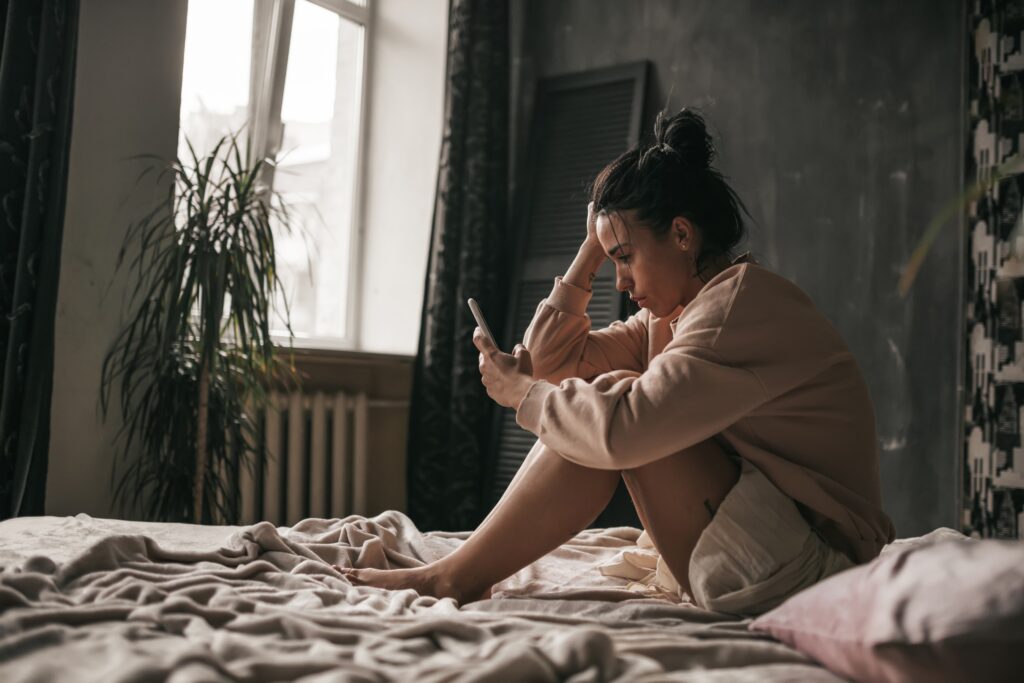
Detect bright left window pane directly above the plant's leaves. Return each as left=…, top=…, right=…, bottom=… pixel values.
left=178, top=0, right=253, bottom=160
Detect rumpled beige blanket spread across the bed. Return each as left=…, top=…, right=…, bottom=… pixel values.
left=0, top=511, right=839, bottom=683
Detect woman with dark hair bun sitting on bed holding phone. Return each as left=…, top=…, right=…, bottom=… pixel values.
left=337, top=110, right=894, bottom=614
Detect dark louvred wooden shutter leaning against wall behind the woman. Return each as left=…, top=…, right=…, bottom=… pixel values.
left=489, top=62, right=647, bottom=525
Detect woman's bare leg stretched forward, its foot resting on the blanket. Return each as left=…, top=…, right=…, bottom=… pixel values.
left=339, top=441, right=621, bottom=602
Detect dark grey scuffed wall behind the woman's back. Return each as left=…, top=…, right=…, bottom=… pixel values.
left=513, top=0, right=965, bottom=537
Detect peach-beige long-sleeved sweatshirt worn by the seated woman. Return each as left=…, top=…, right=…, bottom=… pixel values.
left=516, top=262, right=895, bottom=562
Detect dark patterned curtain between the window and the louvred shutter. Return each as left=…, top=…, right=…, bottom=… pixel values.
left=408, top=0, right=509, bottom=530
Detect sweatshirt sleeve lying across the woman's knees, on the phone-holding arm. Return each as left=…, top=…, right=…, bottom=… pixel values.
left=516, top=344, right=767, bottom=470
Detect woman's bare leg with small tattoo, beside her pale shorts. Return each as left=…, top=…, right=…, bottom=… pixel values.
left=623, top=439, right=739, bottom=593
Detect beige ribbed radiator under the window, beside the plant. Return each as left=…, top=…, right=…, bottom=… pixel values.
left=239, top=392, right=379, bottom=525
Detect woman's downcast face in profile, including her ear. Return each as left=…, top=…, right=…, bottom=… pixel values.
left=597, top=211, right=703, bottom=317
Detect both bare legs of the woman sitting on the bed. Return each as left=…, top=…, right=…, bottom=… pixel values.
left=348, top=440, right=739, bottom=602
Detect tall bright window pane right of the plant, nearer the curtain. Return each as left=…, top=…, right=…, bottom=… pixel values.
left=273, top=0, right=364, bottom=340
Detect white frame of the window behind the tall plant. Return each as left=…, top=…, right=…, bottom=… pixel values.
left=248, top=0, right=373, bottom=351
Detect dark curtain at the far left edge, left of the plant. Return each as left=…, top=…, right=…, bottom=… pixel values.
left=0, top=0, right=78, bottom=517
